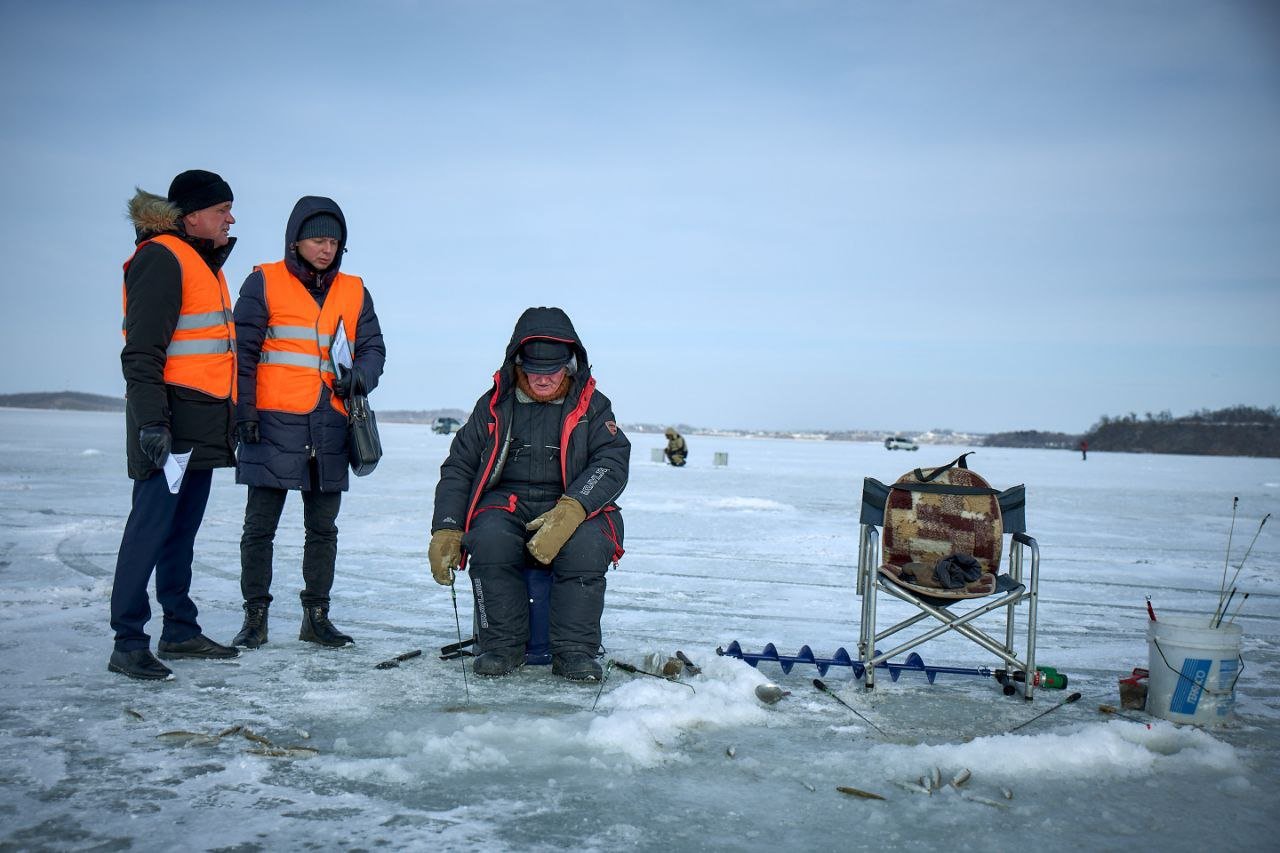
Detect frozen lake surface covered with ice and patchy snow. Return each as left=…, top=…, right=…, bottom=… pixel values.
left=0, top=410, right=1280, bottom=850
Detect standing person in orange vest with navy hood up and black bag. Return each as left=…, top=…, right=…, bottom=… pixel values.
left=232, top=196, right=387, bottom=648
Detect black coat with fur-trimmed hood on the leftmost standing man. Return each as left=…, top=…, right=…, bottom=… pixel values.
left=120, top=190, right=236, bottom=480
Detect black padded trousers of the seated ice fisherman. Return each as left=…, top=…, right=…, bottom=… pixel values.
left=462, top=501, right=616, bottom=654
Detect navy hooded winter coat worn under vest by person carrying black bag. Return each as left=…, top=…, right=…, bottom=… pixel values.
left=236, top=196, right=387, bottom=492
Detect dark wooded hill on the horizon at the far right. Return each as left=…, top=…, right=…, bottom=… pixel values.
left=983, top=406, right=1280, bottom=457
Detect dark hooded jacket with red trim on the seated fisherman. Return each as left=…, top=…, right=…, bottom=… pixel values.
left=431, top=307, right=631, bottom=556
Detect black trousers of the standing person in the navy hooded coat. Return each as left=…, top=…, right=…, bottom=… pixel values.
left=241, top=485, right=342, bottom=607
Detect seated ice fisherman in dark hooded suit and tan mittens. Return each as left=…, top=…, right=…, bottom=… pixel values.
left=428, top=307, right=631, bottom=681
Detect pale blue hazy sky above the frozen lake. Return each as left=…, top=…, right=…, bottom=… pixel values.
left=0, top=0, right=1280, bottom=432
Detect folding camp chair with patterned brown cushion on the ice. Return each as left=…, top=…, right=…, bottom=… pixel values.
left=858, top=453, right=1039, bottom=699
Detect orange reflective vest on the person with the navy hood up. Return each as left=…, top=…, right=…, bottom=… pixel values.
left=255, top=261, right=365, bottom=415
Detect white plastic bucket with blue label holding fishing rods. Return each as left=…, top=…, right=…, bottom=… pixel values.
left=1147, top=616, right=1242, bottom=725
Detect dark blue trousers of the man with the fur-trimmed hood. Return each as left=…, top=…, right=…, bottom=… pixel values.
left=111, top=470, right=214, bottom=652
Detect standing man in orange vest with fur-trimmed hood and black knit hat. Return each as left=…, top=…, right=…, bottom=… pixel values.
left=108, top=169, right=239, bottom=680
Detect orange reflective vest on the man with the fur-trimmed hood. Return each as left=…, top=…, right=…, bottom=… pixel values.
left=120, top=234, right=237, bottom=401
